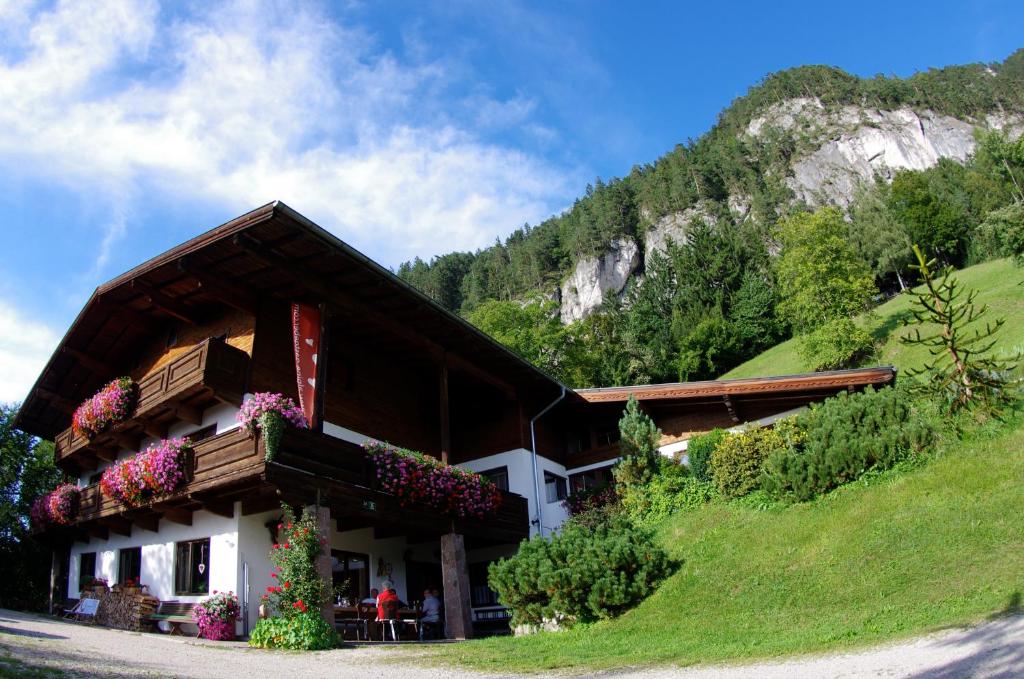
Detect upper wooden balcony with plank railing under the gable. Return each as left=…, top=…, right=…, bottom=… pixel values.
left=54, top=339, right=249, bottom=468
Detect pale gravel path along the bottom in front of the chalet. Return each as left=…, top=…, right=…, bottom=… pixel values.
left=0, top=609, right=1024, bottom=679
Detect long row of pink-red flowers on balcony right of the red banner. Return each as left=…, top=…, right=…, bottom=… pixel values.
left=362, top=440, right=502, bottom=518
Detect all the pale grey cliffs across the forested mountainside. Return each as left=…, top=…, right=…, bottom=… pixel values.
left=560, top=98, right=1024, bottom=324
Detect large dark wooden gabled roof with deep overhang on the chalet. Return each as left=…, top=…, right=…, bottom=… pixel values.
left=14, top=202, right=573, bottom=439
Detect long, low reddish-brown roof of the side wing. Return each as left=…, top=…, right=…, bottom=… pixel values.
left=577, top=366, right=896, bottom=404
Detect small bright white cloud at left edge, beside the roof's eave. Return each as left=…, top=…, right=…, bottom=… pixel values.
left=0, top=300, right=58, bottom=404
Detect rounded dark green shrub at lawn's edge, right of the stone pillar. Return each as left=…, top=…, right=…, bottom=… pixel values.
left=488, top=515, right=670, bottom=625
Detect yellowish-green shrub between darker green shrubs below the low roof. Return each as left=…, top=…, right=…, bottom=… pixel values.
left=711, top=418, right=802, bottom=499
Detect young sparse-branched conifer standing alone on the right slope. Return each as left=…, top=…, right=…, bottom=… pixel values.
left=900, top=245, right=1016, bottom=411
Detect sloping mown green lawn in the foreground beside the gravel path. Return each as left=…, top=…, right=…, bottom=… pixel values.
left=423, top=411, right=1024, bottom=671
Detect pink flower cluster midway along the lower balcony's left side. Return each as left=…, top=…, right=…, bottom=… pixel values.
left=99, top=438, right=193, bottom=507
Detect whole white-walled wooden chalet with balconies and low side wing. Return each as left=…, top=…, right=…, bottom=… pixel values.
left=16, top=203, right=894, bottom=637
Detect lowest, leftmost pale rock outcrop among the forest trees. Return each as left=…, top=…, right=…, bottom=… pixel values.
left=561, top=238, right=640, bottom=325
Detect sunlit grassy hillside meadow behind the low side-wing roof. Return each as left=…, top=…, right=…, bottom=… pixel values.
left=722, top=259, right=1024, bottom=379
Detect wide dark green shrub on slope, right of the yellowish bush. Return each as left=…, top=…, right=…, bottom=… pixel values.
left=762, top=387, right=934, bottom=500
